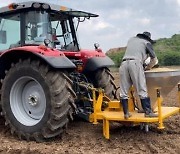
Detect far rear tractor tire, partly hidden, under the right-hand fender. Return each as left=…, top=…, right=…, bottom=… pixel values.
left=90, top=68, right=116, bottom=99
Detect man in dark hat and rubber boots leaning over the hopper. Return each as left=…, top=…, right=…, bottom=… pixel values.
left=119, top=32, right=158, bottom=119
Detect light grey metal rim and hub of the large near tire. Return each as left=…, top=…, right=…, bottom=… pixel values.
left=10, top=76, right=46, bottom=126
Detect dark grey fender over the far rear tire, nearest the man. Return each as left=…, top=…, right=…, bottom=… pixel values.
left=84, top=56, right=114, bottom=72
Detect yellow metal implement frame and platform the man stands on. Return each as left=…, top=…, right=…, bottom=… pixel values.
left=89, top=84, right=180, bottom=139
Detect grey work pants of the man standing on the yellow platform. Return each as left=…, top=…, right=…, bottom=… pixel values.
left=119, top=60, right=148, bottom=99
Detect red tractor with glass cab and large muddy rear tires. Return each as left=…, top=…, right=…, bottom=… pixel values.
left=0, top=2, right=116, bottom=141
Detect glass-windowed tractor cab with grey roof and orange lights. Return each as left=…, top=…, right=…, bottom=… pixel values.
left=0, top=2, right=98, bottom=51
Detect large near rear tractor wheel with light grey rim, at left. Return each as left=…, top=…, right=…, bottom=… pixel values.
left=2, top=60, right=75, bottom=142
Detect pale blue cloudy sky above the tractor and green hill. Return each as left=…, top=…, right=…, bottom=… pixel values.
left=0, top=0, right=180, bottom=52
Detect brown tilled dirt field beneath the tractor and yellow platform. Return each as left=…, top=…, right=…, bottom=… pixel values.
left=0, top=72, right=180, bottom=154
